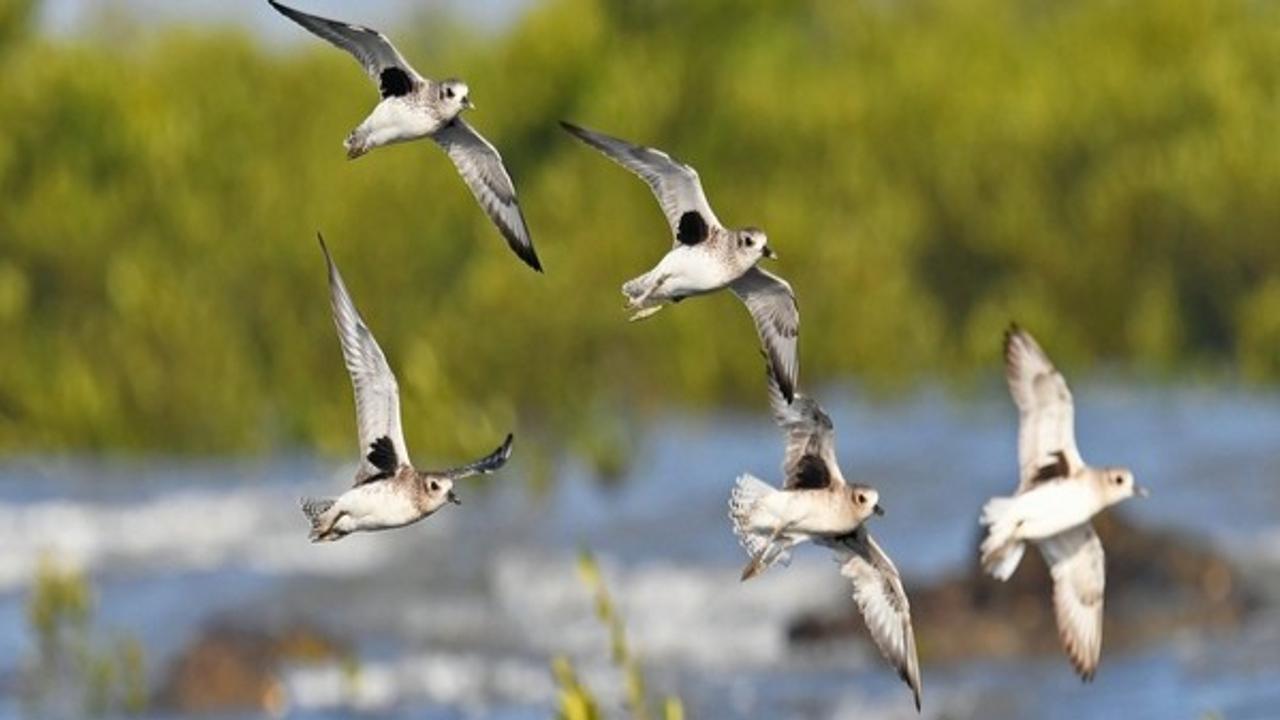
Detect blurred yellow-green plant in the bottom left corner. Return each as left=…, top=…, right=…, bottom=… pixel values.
left=22, top=557, right=147, bottom=717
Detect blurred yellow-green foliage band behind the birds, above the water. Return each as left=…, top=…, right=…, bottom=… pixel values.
left=0, top=0, right=1280, bottom=456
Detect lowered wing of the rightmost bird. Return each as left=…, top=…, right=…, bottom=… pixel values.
left=1039, top=523, right=1107, bottom=680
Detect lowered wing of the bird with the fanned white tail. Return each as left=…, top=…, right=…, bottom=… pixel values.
left=832, top=525, right=922, bottom=711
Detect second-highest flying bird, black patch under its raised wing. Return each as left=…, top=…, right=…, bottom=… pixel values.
left=561, top=120, right=800, bottom=402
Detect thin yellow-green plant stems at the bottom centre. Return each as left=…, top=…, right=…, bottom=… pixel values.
left=552, top=550, right=685, bottom=720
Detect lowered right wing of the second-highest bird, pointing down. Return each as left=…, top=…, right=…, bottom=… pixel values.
left=728, top=268, right=800, bottom=402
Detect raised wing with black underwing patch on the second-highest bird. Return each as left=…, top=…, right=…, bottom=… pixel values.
left=561, top=120, right=723, bottom=245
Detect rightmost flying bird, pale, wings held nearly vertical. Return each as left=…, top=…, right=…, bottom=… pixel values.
left=980, top=324, right=1148, bottom=682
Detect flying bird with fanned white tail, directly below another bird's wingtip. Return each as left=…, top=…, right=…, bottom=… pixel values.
left=728, top=361, right=922, bottom=712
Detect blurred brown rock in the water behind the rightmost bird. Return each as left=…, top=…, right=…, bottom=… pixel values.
left=790, top=512, right=1261, bottom=662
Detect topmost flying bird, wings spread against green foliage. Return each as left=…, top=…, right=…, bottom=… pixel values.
left=268, top=0, right=543, bottom=272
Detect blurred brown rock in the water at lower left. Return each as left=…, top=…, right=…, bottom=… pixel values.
left=156, top=625, right=348, bottom=716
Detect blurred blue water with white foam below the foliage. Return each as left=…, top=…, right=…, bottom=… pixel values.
left=0, top=384, right=1280, bottom=720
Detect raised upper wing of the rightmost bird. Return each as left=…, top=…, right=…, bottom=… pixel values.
left=1005, top=325, right=1084, bottom=493
